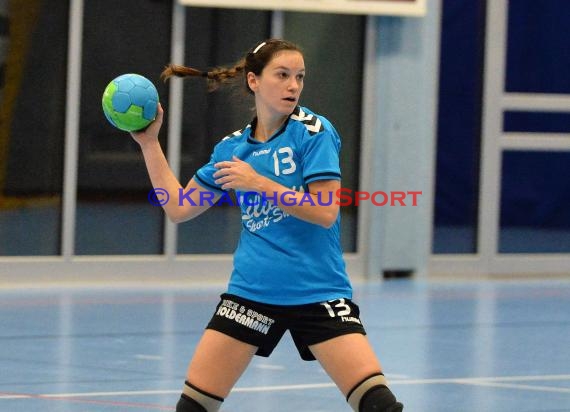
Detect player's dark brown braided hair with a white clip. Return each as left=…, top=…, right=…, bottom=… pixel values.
left=160, top=39, right=302, bottom=94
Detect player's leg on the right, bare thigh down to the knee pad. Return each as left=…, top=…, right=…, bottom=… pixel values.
left=310, top=333, right=403, bottom=412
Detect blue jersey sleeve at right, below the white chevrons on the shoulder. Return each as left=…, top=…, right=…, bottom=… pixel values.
left=301, top=128, right=341, bottom=184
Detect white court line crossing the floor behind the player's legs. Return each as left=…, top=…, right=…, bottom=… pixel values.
left=0, top=375, right=570, bottom=401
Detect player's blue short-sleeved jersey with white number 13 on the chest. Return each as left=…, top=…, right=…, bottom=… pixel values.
left=194, top=106, right=352, bottom=305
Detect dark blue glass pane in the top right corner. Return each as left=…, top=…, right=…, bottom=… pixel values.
left=506, top=0, right=570, bottom=93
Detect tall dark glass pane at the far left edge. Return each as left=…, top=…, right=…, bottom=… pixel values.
left=0, top=1, right=69, bottom=256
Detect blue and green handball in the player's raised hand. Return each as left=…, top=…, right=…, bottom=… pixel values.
left=102, top=73, right=158, bottom=132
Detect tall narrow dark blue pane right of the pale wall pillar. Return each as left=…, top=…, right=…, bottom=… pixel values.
left=433, top=0, right=485, bottom=253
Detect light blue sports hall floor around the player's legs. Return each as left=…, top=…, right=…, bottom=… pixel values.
left=0, top=280, right=570, bottom=412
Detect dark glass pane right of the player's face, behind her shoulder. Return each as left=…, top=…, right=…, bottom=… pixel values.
left=284, top=12, right=367, bottom=252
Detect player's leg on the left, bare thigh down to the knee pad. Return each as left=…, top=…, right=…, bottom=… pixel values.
left=176, top=329, right=257, bottom=412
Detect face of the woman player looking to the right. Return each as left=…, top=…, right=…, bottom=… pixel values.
left=248, top=50, right=305, bottom=116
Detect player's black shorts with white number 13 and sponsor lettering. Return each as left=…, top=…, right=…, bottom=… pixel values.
left=206, top=293, right=366, bottom=361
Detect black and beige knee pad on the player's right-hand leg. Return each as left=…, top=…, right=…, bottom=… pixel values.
left=346, top=373, right=403, bottom=412
